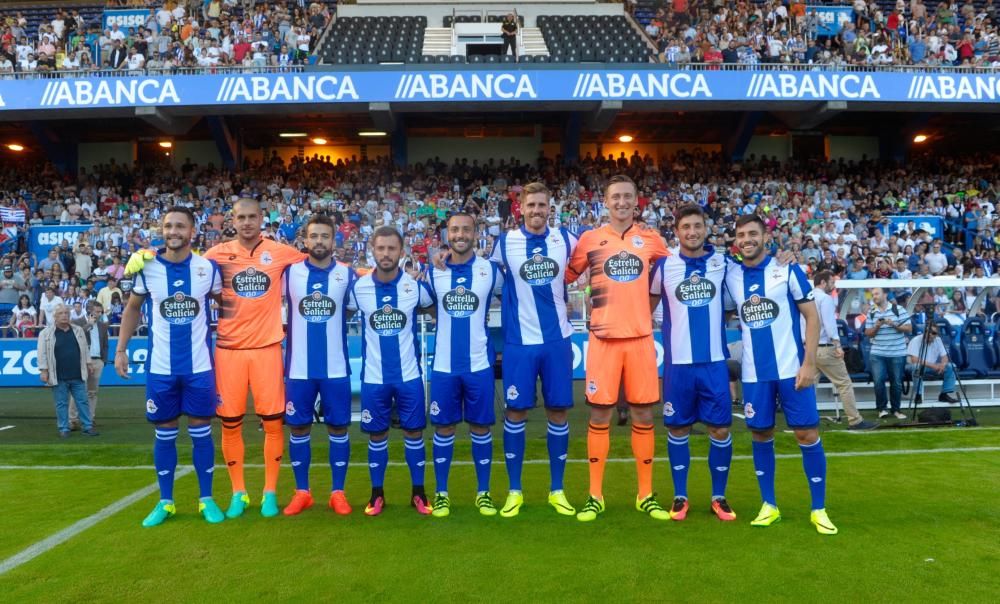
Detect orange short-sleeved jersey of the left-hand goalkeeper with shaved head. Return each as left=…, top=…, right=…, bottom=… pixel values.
left=205, top=237, right=306, bottom=350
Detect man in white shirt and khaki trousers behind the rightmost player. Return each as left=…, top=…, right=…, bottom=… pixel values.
left=813, top=271, right=878, bottom=430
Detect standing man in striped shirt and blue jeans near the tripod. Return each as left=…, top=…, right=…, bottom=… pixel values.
left=865, top=287, right=913, bottom=419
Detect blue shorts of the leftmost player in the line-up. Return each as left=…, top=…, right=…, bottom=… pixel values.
left=146, top=371, right=219, bottom=424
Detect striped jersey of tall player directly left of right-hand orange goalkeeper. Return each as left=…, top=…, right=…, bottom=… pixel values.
left=490, top=226, right=577, bottom=345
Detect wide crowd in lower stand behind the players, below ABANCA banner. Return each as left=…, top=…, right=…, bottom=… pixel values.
left=0, top=146, right=1000, bottom=333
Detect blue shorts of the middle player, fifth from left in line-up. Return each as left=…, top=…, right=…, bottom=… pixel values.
left=430, top=367, right=497, bottom=426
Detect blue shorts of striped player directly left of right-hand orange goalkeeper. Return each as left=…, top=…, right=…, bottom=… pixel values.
left=503, top=338, right=573, bottom=410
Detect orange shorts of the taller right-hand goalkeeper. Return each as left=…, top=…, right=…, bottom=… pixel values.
left=586, top=333, right=660, bottom=406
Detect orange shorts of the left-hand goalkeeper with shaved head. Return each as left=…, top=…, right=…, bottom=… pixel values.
left=215, top=343, right=285, bottom=420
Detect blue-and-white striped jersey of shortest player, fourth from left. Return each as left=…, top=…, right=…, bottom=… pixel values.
left=347, top=269, right=434, bottom=384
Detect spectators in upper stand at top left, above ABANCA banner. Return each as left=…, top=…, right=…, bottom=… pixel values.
left=0, top=0, right=332, bottom=76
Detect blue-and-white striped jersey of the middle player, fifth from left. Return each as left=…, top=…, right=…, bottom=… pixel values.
left=427, top=256, right=504, bottom=374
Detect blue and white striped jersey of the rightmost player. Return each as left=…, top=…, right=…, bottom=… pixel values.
left=726, top=256, right=813, bottom=382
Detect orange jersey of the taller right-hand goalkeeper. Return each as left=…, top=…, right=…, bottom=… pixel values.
left=566, top=225, right=670, bottom=339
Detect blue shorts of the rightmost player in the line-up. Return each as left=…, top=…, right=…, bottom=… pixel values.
left=743, top=378, right=819, bottom=430
